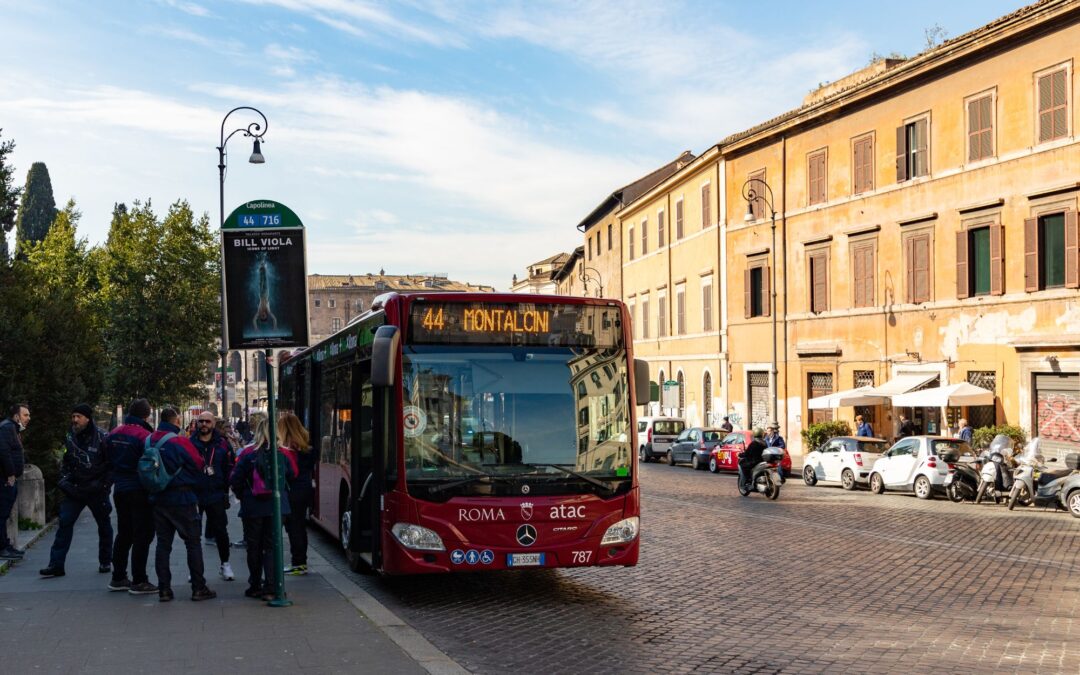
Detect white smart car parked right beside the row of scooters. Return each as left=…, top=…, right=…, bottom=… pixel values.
left=870, top=436, right=973, bottom=499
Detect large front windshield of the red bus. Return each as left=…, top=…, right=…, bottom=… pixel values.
left=402, top=346, right=632, bottom=491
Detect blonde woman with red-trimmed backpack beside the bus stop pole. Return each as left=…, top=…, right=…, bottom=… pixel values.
left=229, top=417, right=297, bottom=600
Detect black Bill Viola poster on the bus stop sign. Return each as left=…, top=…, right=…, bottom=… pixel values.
left=221, top=224, right=308, bottom=349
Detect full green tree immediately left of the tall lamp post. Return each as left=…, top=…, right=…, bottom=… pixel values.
left=98, top=201, right=220, bottom=405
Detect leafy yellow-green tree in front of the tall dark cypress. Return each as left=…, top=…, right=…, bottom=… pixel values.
left=0, top=202, right=105, bottom=494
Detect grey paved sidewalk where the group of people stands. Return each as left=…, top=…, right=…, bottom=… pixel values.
left=0, top=511, right=430, bottom=674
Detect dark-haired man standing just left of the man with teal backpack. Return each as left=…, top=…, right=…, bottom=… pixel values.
left=102, top=399, right=158, bottom=595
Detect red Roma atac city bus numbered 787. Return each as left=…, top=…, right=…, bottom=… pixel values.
left=279, top=293, right=648, bottom=575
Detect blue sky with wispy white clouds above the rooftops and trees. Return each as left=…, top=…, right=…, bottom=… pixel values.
left=0, top=0, right=1021, bottom=288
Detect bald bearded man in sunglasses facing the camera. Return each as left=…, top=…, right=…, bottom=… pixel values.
left=191, top=413, right=235, bottom=581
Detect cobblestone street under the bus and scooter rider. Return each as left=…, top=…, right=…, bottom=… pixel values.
left=313, top=464, right=1080, bottom=673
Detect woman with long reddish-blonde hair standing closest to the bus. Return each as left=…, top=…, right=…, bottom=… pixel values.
left=278, top=413, right=319, bottom=577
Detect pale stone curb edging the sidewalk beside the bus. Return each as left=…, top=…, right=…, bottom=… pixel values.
left=308, top=548, right=469, bottom=675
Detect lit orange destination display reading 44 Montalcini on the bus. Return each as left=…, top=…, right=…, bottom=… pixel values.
left=409, top=301, right=621, bottom=347
